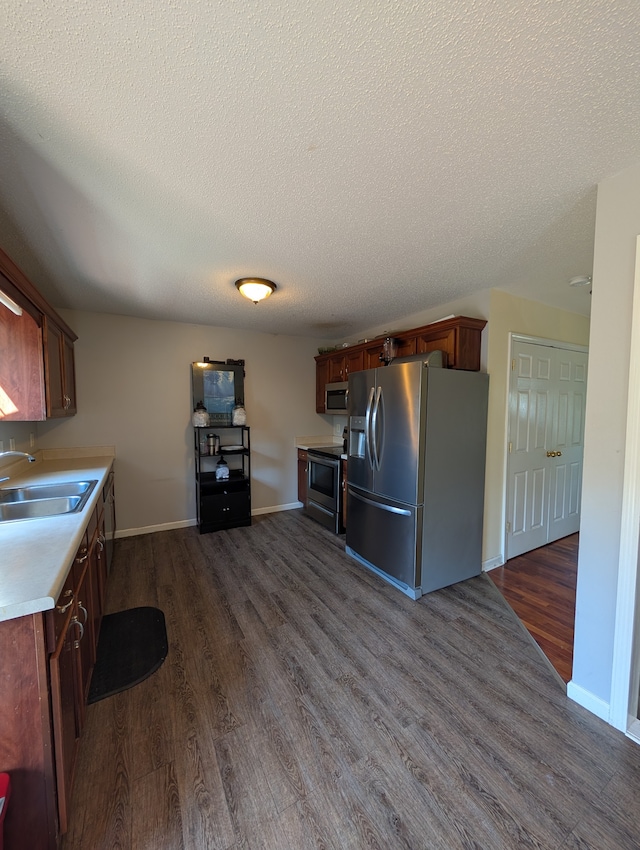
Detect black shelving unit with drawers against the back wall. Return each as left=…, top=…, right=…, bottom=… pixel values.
left=193, top=425, right=251, bottom=534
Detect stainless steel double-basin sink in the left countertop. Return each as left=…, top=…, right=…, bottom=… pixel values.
left=0, top=480, right=98, bottom=522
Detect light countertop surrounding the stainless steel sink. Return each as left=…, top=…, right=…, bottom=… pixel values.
left=0, top=447, right=115, bottom=621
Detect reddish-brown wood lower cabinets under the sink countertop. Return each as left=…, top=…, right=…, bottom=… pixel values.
left=0, top=505, right=106, bottom=850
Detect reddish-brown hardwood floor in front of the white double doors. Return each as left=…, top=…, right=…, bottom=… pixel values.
left=488, top=534, right=579, bottom=683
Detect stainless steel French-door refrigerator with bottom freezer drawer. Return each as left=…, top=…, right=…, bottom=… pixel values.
left=346, top=355, right=489, bottom=599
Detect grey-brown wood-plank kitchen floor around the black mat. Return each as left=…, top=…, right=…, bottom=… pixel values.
left=63, top=511, right=640, bottom=850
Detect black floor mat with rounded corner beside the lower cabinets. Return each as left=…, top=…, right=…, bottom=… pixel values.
left=88, top=607, right=169, bottom=703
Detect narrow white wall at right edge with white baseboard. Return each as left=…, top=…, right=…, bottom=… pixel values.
left=568, top=165, right=640, bottom=716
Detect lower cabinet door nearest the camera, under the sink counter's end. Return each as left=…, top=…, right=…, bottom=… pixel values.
left=49, top=605, right=81, bottom=833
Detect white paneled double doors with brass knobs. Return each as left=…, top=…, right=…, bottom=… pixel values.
left=506, top=339, right=588, bottom=560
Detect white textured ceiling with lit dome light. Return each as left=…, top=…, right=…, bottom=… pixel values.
left=0, top=0, right=640, bottom=338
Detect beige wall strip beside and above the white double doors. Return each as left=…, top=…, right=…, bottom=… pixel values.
left=483, top=289, right=589, bottom=569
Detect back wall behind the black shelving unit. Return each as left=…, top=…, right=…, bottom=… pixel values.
left=31, top=308, right=332, bottom=531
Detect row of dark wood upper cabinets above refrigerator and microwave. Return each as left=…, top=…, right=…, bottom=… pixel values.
left=315, top=316, right=487, bottom=413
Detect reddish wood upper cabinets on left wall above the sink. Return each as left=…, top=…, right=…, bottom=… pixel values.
left=0, top=250, right=77, bottom=422
